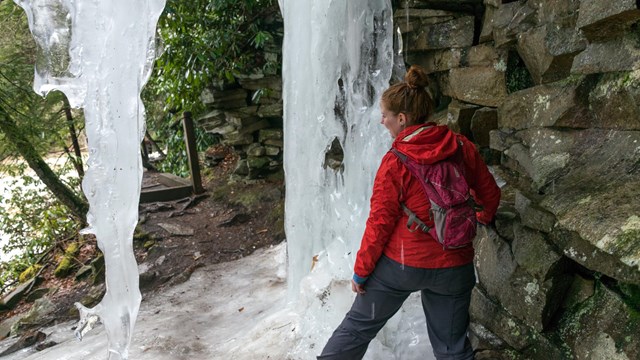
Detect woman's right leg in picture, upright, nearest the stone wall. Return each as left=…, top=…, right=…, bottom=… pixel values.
left=421, top=264, right=475, bottom=360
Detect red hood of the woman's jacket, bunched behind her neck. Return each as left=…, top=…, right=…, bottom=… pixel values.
left=393, top=122, right=458, bottom=164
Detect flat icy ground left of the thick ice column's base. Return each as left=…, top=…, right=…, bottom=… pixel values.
left=0, top=243, right=295, bottom=360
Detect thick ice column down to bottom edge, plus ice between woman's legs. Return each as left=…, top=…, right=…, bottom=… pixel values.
left=280, top=0, right=431, bottom=359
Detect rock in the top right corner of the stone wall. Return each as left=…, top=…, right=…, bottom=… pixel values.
left=577, top=0, right=640, bottom=41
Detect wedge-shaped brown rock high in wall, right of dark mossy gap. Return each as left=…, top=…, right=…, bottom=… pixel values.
left=517, top=24, right=587, bottom=84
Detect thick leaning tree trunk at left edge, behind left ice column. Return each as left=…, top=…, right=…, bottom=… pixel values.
left=0, top=105, right=89, bottom=222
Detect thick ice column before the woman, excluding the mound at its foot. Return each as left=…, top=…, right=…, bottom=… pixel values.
left=280, top=0, right=393, bottom=296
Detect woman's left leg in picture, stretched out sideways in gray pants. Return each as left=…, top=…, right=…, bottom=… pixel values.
left=318, top=261, right=412, bottom=360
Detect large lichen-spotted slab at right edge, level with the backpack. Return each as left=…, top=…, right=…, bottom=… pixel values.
left=540, top=130, right=640, bottom=284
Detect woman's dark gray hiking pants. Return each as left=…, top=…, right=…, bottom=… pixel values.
left=318, top=256, right=476, bottom=360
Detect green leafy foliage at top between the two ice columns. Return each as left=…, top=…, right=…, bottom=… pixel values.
left=149, top=0, right=281, bottom=113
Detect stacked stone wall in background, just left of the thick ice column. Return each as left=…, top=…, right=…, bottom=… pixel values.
left=197, top=62, right=283, bottom=179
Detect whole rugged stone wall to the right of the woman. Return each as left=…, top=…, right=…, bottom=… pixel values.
left=394, top=0, right=640, bottom=359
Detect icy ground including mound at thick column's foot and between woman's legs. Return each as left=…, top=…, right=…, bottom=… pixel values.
left=0, top=242, right=431, bottom=360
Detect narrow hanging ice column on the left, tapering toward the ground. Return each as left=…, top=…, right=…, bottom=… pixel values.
left=15, top=0, right=165, bottom=360
